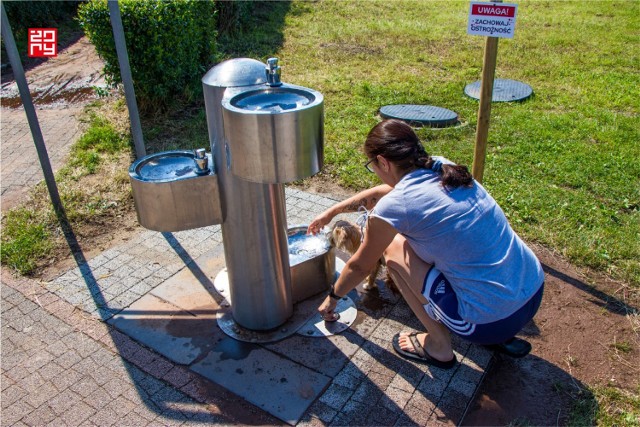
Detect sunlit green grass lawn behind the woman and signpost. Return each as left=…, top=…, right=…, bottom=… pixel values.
left=252, top=1, right=640, bottom=291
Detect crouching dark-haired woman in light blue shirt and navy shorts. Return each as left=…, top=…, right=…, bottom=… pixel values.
left=308, top=120, right=544, bottom=368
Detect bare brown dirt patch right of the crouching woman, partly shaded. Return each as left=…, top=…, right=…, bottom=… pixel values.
left=463, top=246, right=640, bottom=425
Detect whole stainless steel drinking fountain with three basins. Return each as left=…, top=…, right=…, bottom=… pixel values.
left=129, top=58, right=355, bottom=342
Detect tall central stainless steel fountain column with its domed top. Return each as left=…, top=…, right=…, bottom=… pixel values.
left=202, top=58, right=293, bottom=330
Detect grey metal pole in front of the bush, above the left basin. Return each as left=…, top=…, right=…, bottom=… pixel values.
left=108, top=0, right=146, bottom=159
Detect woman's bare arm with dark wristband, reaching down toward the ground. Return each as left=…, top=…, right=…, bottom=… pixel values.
left=318, top=217, right=398, bottom=318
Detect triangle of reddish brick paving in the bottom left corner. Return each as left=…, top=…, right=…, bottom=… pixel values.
left=1, top=271, right=279, bottom=426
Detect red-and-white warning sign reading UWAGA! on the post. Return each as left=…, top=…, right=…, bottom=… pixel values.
left=467, top=2, right=518, bottom=39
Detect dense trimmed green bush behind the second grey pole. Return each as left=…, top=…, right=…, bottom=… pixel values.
left=78, top=0, right=217, bottom=114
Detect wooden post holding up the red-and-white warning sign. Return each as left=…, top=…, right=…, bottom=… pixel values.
left=472, top=0, right=502, bottom=183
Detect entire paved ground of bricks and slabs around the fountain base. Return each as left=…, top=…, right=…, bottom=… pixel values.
left=2, top=189, right=491, bottom=425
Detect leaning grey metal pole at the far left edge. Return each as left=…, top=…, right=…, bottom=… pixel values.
left=0, top=4, right=64, bottom=215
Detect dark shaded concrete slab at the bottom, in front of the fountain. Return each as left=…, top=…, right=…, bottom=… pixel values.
left=191, top=337, right=331, bottom=425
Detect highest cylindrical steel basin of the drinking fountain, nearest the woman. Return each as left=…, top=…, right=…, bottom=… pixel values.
left=222, top=84, right=324, bottom=184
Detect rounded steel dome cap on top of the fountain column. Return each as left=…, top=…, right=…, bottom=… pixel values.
left=202, top=58, right=267, bottom=87
